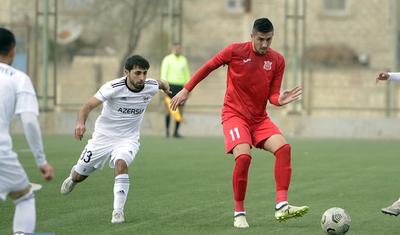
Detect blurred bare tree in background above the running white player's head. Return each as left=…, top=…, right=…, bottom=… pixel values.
left=60, top=0, right=162, bottom=76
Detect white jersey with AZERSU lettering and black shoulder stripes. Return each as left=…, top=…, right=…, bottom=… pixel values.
left=94, top=77, right=159, bottom=140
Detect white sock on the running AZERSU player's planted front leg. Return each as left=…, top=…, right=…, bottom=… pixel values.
left=114, top=174, right=129, bottom=212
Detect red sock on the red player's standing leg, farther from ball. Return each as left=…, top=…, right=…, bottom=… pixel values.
left=232, top=154, right=251, bottom=211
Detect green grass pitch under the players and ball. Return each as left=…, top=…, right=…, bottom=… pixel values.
left=0, top=136, right=400, bottom=235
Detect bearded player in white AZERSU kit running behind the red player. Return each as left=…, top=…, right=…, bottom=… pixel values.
left=61, top=55, right=170, bottom=224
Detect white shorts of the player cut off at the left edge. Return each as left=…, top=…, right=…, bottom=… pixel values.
left=0, top=152, right=29, bottom=200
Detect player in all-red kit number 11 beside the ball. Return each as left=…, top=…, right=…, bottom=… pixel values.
left=171, top=18, right=309, bottom=228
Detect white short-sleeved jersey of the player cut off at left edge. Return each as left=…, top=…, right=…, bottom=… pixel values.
left=0, top=63, right=39, bottom=160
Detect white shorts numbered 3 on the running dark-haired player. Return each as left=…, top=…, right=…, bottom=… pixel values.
left=75, top=133, right=140, bottom=175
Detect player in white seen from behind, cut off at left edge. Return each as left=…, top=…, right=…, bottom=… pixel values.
left=0, top=28, right=53, bottom=233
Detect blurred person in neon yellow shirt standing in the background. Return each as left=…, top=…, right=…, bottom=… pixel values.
left=161, top=43, right=190, bottom=138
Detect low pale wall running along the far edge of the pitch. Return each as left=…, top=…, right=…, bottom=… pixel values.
left=12, top=108, right=400, bottom=139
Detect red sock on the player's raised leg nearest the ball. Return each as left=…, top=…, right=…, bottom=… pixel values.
left=274, top=144, right=292, bottom=203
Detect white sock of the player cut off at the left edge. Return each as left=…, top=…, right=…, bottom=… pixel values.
left=13, top=192, right=36, bottom=233
